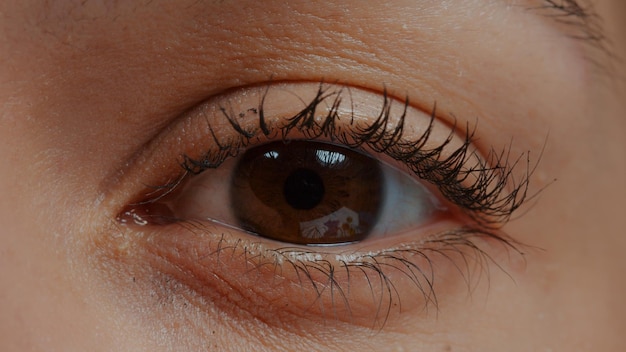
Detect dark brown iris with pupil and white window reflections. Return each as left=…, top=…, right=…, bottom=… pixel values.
left=230, top=141, right=383, bottom=244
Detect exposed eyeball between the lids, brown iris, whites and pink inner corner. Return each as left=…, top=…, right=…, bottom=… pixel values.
left=127, top=140, right=438, bottom=245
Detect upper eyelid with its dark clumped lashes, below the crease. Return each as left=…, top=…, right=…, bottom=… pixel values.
left=109, top=83, right=529, bottom=231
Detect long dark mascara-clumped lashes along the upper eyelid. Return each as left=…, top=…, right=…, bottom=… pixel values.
left=178, top=83, right=536, bottom=229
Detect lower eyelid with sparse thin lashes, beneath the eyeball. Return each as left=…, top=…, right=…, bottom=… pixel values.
left=112, top=222, right=512, bottom=330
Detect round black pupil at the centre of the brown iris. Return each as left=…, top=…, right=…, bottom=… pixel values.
left=283, top=169, right=325, bottom=210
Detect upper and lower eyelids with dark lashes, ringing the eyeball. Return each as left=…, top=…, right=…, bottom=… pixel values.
left=114, top=83, right=532, bottom=328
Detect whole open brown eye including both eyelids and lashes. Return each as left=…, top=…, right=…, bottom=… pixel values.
left=111, top=83, right=529, bottom=328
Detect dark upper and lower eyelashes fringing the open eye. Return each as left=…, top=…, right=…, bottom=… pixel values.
left=118, top=83, right=534, bottom=329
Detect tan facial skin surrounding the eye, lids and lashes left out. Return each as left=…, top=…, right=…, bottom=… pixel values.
left=0, top=0, right=626, bottom=351
